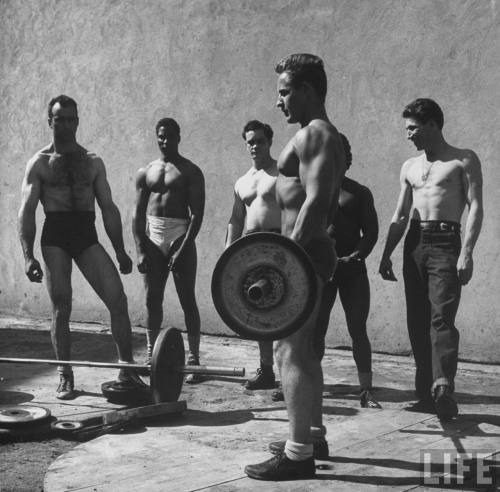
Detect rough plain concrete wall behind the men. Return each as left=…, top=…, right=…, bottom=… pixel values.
left=0, top=0, right=500, bottom=361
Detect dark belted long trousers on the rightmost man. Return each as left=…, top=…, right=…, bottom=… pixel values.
left=403, top=221, right=461, bottom=399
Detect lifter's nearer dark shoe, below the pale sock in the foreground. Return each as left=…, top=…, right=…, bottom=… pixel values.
left=245, top=453, right=316, bottom=481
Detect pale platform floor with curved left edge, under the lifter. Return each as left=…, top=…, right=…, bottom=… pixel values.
left=44, top=349, right=500, bottom=492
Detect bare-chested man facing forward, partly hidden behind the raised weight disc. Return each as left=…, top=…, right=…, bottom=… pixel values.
left=226, top=120, right=281, bottom=390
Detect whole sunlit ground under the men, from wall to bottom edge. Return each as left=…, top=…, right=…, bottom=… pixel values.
left=0, top=317, right=500, bottom=492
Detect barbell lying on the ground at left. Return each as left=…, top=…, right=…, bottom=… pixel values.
left=0, top=328, right=245, bottom=403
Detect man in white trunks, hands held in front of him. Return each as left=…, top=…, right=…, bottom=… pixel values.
left=132, top=118, right=205, bottom=383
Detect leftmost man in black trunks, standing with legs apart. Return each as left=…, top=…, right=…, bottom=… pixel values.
left=18, top=95, right=144, bottom=400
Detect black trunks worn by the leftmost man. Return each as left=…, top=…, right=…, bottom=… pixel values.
left=41, top=210, right=98, bottom=259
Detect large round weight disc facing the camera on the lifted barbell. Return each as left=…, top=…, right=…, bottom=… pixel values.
left=212, top=232, right=317, bottom=340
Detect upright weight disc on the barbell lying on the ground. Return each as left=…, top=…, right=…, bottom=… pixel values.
left=151, top=328, right=185, bottom=403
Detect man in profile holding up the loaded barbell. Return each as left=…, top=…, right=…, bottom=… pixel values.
left=245, top=54, right=345, bottom=480
